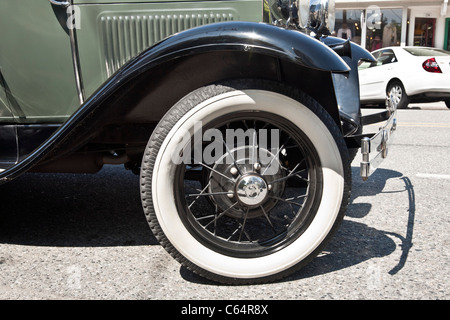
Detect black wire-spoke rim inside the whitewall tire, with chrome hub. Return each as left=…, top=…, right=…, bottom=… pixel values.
left=174, top=112, right=322, bottom=258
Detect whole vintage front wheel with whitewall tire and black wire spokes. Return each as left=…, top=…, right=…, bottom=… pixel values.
left=140, top=80, right=351, bottom=284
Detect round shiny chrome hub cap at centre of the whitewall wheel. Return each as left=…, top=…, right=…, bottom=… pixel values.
left=235, top=174, right=268, bottom=206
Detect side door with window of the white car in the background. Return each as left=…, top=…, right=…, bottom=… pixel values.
left=359, top=49, right=397, bottom=101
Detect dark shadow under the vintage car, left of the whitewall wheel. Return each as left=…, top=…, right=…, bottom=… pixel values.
left=0, top=167, right=158, bottom=247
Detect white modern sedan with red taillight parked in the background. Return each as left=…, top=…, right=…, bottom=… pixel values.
left=358, top=47, right=450, bottom=109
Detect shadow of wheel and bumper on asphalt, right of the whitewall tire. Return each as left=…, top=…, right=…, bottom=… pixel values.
left=180, top=168, right=415, bottom=285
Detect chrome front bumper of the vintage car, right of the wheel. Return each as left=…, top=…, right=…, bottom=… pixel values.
left=361, top=105, right=397, bottom=181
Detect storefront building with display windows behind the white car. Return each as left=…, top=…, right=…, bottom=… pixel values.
left=334, top=0, right=450, bottom=51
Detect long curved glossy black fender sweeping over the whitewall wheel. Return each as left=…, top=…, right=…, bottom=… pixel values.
left=0, top=22, right=350, bottom=183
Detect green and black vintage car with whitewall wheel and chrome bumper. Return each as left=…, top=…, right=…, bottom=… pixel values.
left=0, top=0, right=396, bottom=284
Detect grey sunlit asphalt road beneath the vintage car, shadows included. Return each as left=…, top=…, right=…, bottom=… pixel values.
left=0, top=103, right=450, bottom=300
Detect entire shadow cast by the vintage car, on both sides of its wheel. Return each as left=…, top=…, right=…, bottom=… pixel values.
left=0, top=167, right=415, bottom=284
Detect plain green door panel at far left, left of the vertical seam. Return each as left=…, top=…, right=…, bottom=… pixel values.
left=0, top=0, right=79, bottom=124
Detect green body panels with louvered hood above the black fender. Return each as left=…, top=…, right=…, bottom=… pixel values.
left=0, top=0, right=263, bottom=123
